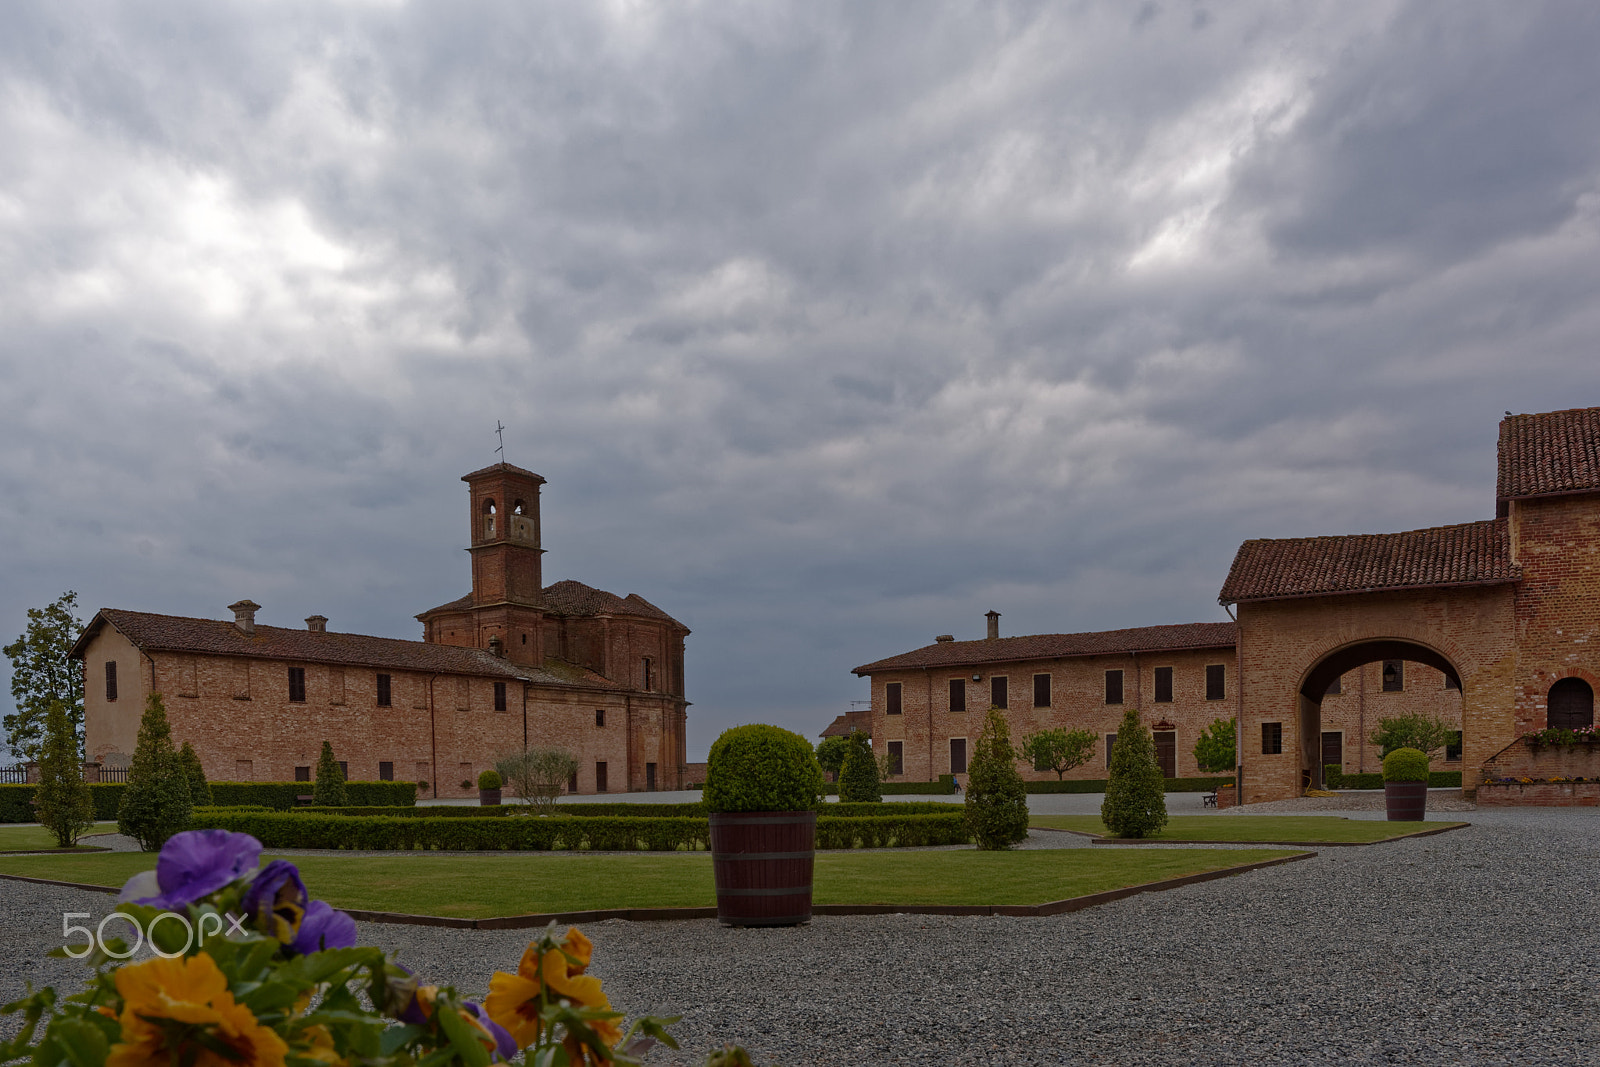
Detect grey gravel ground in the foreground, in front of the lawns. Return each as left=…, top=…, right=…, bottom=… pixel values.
left=0, top=805, right=1600, bottom=1065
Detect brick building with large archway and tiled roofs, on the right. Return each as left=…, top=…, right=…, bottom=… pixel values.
left=854, top=408, right=1600, bottom=803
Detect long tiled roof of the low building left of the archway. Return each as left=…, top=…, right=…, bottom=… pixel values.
left=853, top=622, right=1238, bottom=675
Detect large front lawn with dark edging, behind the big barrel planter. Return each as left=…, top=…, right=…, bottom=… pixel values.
left=0, top=848, right=1294, bottom=918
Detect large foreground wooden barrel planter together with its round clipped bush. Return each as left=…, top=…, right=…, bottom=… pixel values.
left=704, top=725, right=822, bottom=926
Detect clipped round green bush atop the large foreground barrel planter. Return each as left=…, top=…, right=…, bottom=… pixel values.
left=706, top=723, right=822, bottom=811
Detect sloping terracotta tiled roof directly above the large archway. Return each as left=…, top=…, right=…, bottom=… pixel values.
left=1218, top=518, right=1520, bottom=603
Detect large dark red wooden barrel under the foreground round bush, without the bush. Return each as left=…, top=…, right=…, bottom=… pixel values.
left=710, top=811, right=816, bottom=926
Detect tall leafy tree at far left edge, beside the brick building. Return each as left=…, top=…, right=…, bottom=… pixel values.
left=0, top=589, right=83, bottom=760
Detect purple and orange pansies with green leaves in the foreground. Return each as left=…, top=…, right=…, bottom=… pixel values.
left=0, top=830, right=750, bottom=1067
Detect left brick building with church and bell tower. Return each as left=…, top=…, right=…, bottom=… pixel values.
left=72, top=464, right=688, bottom=797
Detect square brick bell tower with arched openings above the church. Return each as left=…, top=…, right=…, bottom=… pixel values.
left=461, top=462, right=544, bottom=608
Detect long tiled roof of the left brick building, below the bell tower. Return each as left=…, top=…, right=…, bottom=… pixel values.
left=72, top=608, right=624, bottom=689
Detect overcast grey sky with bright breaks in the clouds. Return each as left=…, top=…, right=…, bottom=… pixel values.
left=0, top=0, right=1600, bottom=758
